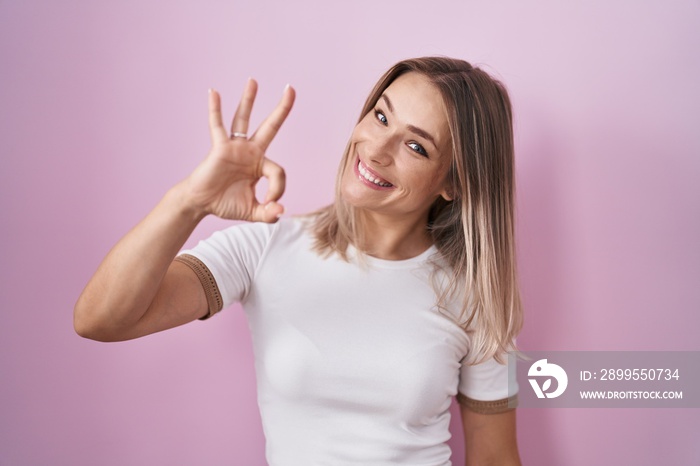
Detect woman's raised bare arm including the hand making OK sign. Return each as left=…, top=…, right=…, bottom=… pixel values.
left=73, top=80, right=294, bottom=341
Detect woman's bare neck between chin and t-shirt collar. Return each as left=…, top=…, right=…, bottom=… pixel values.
left=356, top=211, right=433, bottom=260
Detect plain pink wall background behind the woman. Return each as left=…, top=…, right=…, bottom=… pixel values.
left=0, top=0, right=700, bottom=466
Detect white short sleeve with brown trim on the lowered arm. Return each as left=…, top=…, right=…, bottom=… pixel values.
left=457, top=357, right=518, bottom=414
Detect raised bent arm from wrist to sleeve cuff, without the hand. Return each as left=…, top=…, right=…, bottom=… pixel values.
left=74, top=186, right=207, bottom=341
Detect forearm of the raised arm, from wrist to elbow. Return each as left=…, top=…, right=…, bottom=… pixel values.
left=74, top=183, right=204, bottom=340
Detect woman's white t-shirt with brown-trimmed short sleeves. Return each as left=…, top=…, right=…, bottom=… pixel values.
left=183, top=219, right=517, bottom=466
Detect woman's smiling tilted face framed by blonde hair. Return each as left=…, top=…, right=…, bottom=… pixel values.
left=341, top=72, right=452, bottom=222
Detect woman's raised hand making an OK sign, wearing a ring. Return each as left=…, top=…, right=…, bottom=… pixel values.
left=185, top=79, right=295, bottom=222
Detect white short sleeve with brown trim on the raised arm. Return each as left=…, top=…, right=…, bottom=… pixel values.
left=176, top=223, right=274, bottom=317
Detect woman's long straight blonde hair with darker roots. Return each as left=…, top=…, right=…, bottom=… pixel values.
left=312, top=57, right=523, bottom=363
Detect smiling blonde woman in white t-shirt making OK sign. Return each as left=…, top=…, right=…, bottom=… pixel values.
left=75, top=57, right=522, bottom=465
